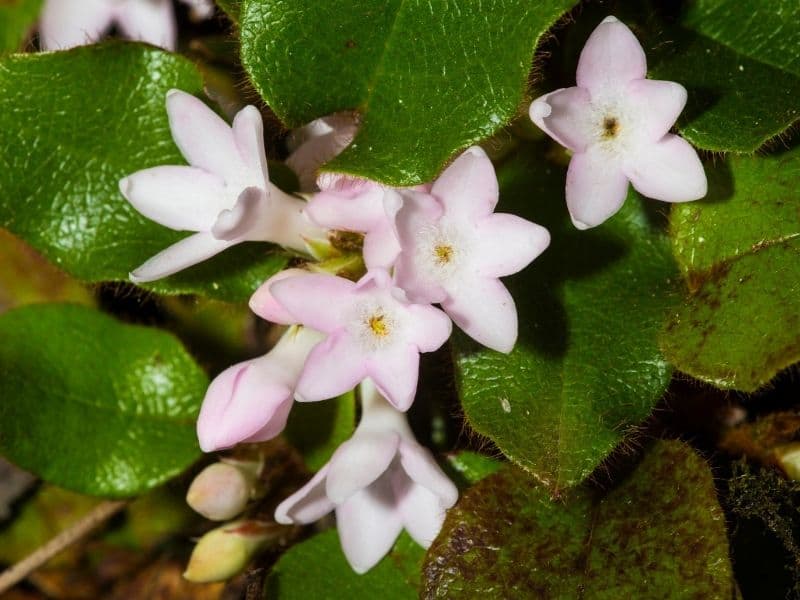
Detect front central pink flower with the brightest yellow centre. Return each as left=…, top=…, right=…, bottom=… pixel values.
left=269, top=269, right=452, bottom=410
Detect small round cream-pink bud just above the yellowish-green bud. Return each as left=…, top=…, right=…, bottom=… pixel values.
left=186, top=461, right=258, bottom=521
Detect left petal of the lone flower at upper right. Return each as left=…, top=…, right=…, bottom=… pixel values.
left=528, top=87, right=592, bottom=152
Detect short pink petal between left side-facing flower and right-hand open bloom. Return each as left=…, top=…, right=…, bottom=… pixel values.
left=306, top=184, right=387, bottom=233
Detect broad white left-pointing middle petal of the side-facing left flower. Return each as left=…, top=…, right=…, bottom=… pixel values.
left=119, top=166, right=228, bottom=231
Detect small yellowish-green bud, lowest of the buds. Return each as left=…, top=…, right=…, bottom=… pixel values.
left=183, top=521, right=280, bottom=583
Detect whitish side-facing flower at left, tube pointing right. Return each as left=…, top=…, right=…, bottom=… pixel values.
left=119, top=90, right=327, bottom=282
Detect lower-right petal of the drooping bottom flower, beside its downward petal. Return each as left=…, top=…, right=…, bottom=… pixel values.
left=392, top=471, right=447, bottom=548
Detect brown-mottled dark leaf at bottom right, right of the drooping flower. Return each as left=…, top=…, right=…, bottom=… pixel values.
left=423, top=441, right=733, bottom=600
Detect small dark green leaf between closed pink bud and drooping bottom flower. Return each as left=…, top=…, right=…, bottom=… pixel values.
left=284, top=392, right=356, bottom=471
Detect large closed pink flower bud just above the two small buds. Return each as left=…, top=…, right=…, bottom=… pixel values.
left=197, top=328, right=322, bottom=452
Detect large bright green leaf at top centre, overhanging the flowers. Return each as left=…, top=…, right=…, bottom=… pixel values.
left=241, top=0, right=575, bottom=185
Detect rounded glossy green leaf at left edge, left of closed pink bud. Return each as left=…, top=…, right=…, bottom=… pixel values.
left=0, top=304, right=208, bottom=497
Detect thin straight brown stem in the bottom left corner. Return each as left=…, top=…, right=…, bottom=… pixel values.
left=0, top=500, right=128, bottom=594
